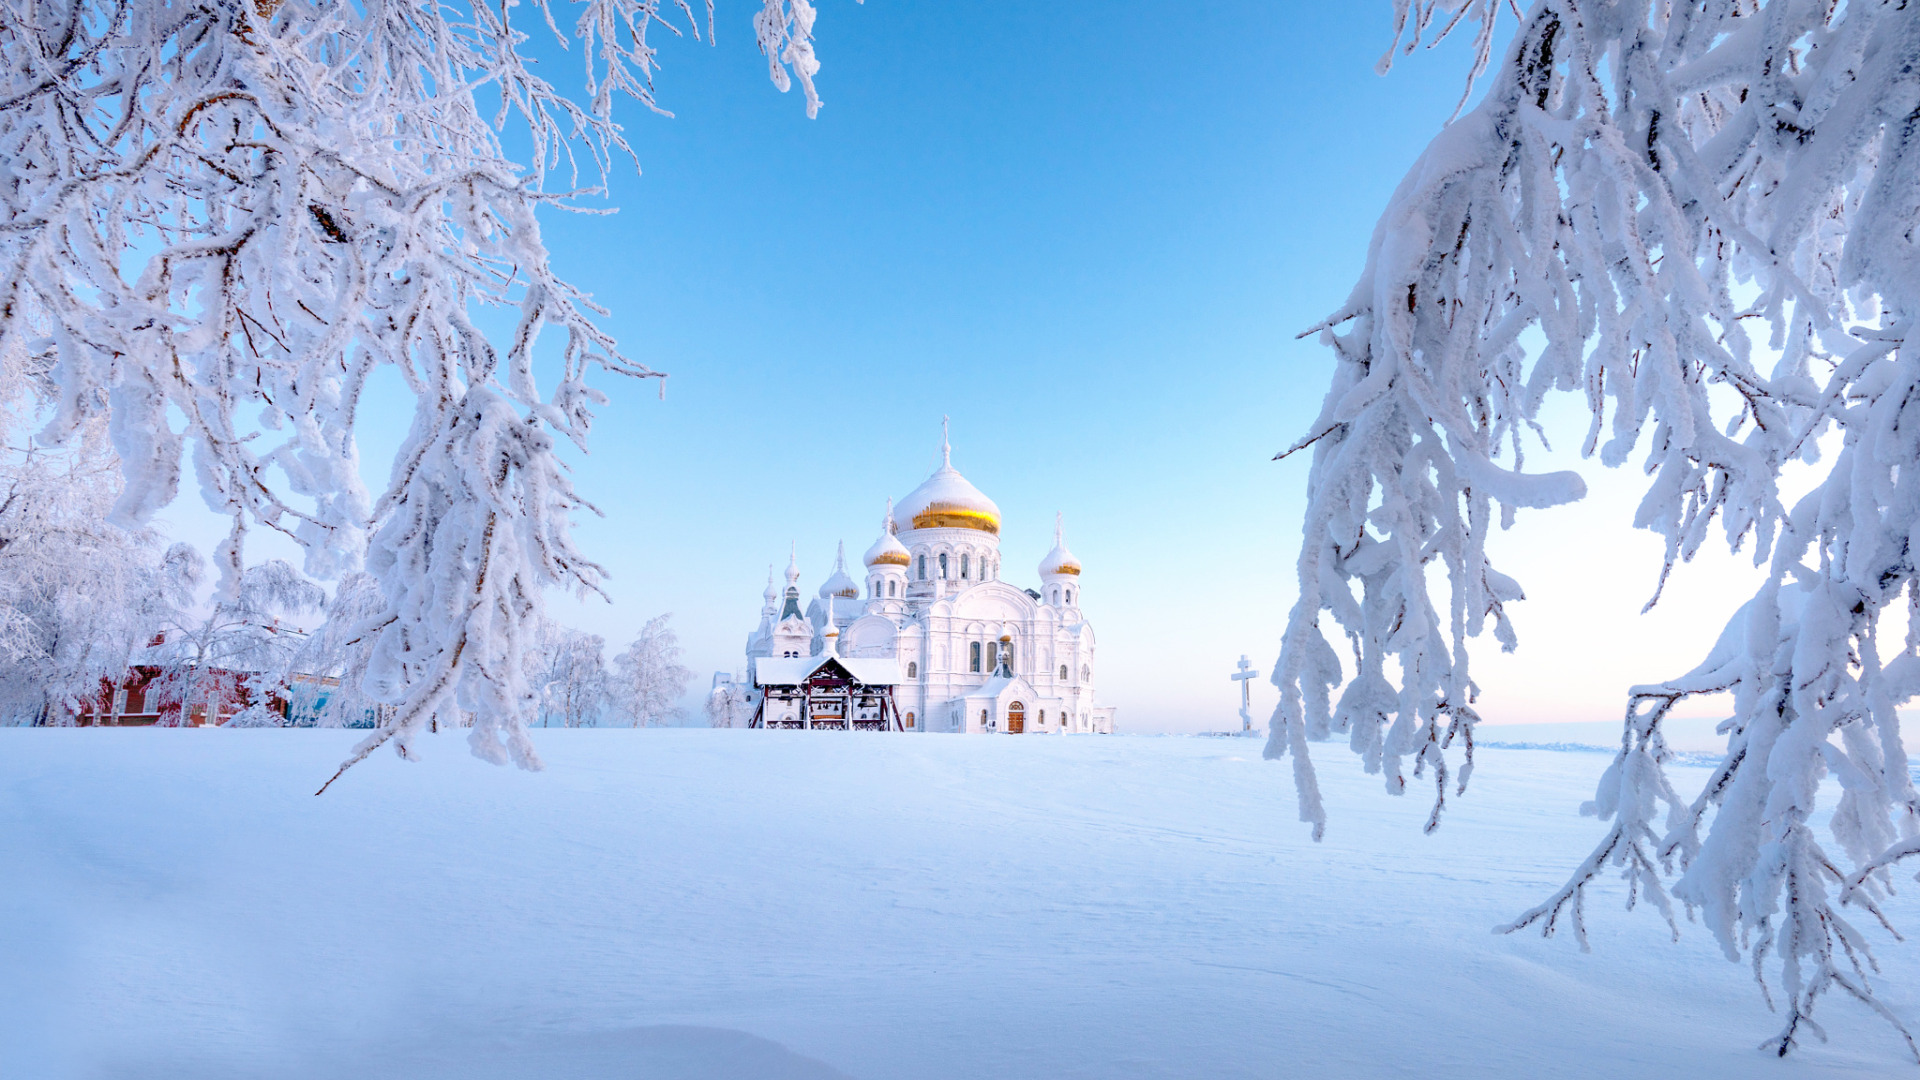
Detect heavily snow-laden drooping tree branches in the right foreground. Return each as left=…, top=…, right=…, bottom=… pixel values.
left=1267, top=0, right=1920, bottom=1053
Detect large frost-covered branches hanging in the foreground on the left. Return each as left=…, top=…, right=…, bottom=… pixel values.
left=0, top=0, right=820, bottom=767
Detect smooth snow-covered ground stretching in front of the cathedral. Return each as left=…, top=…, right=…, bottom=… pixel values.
left=0, top=728, right=1920, bottom=1080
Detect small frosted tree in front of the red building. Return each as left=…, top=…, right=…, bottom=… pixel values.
left=142, top=559, right=326, bottom=726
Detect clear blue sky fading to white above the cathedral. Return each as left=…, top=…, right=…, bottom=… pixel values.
left=172, top=0, right=1774, bottom=730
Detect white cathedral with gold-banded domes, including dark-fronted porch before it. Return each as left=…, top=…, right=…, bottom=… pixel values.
left=737, top=430, right=1114, bottom=734
